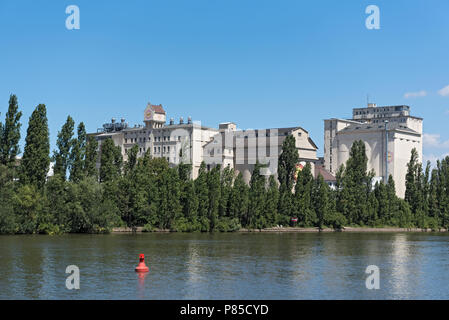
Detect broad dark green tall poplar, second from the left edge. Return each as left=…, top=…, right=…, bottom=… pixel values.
left=20, top=104, right=50, bottom=189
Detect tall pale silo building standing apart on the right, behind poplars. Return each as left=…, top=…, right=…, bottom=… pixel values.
left=324, top=103, right=423, bottom=197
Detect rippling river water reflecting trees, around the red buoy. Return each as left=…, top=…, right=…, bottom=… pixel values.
left=0, top=232, right=449, bottom=300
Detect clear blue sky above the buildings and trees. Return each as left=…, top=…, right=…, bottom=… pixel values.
left=0, top=0, right=449, bottom=159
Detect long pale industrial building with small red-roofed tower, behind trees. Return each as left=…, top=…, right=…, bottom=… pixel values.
left=90, top=103, right=318, bottom=182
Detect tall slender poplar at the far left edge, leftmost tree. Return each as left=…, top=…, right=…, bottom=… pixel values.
left=0, top=95, right=22, bottom=167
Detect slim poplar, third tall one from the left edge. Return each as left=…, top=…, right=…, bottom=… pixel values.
left=53, top=116, right=75, bottom=179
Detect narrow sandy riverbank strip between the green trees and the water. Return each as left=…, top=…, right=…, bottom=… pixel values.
left=112, top=227, right=447, bottom=233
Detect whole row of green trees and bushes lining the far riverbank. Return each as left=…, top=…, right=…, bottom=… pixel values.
left=0, top=95, right=449, bottom=234
